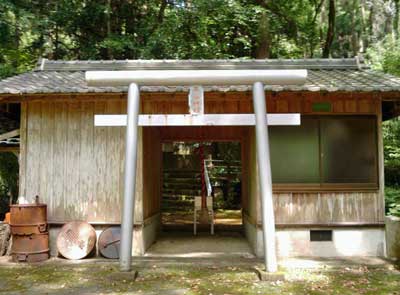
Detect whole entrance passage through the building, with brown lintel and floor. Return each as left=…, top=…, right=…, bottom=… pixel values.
left=144, top=126, right=254, bottom=257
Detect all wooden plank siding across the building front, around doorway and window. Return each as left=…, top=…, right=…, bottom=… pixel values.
left=20, top=92, right=384, bottom=225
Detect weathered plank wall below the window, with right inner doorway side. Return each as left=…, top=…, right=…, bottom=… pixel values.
left=243, top=113, right=385, bottom=227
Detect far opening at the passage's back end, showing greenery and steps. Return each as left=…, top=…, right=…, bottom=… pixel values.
left=161, top=141, right=242, bottom=233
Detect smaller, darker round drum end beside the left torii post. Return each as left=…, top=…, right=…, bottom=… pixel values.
left=99, top=226, right=121, bottom=259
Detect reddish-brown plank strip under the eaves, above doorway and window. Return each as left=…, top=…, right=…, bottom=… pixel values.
left=141, top=92, right=381, bottom=114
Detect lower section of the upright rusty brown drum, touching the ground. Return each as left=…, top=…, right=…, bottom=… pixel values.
left=11, top=233, right=49, bottom=262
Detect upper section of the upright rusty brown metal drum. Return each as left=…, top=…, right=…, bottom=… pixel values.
left=10, top=204, right=48, bottom=235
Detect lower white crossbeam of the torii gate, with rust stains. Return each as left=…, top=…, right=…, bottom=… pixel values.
left=94, top=114, right=300, bottom=126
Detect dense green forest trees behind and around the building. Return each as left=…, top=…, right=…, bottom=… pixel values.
left=0, top=0, right=400, bottom=215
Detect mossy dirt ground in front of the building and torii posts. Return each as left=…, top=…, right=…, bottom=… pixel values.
left=0, top=257, right=400, bottom=295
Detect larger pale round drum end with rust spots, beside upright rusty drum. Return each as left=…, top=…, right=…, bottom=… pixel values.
left=57, top=221, right=96, bottom=259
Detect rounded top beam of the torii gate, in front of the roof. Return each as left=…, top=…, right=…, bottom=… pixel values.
left=85, top=70, right=307, bottom=86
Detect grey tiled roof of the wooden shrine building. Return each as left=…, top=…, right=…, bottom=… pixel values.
left=0, top=58, right=400, bottom=95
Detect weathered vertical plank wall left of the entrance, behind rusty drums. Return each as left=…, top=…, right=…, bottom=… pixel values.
left=20, top=100, right=142, bottom=223
